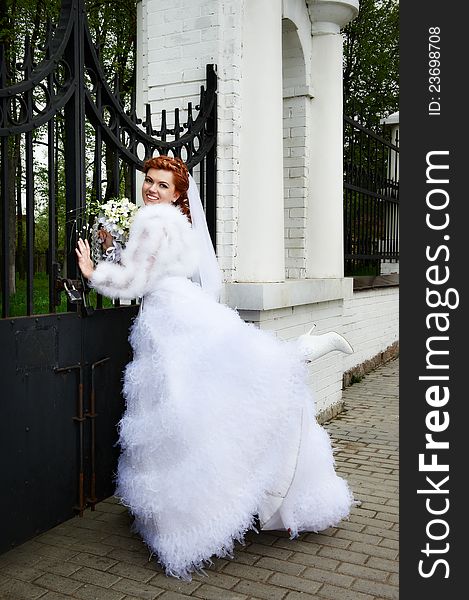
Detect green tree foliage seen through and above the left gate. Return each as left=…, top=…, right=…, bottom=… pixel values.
left=0, top=0, right=137, bottom=268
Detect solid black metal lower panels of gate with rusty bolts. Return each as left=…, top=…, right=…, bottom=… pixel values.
left=0, top=307, right=136, bottom=551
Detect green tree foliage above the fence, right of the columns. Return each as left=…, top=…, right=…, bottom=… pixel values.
left=343, top=0, right=399, bottom=124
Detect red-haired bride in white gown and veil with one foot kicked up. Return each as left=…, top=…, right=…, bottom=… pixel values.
left=76, top=156, right=353, bottom=579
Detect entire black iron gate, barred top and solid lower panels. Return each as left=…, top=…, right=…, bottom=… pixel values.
left=0, top=0, right=216, bottom=551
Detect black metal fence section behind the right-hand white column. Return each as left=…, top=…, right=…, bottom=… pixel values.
left=344, top=115, right=399, bottom=275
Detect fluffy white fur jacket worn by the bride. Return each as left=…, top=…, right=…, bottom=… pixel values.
left=90, top=204, right=198, bottom=298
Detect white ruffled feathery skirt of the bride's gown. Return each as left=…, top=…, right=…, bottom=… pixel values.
left=116, top=277, right=353, bottom=578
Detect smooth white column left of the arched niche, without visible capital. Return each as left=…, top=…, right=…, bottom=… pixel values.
left=235, top=0, right=285, bottom=282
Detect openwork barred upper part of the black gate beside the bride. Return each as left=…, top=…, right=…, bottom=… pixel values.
left=0, top=0, right=216, bottom=317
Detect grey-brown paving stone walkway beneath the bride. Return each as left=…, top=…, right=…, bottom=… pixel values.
left=0, top=360, right=399, bottom=600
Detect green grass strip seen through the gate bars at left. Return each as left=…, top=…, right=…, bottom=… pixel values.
left=3, top=273, right=113, bottom=317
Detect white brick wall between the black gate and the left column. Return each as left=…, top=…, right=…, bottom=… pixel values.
left=138, top=0, right=243, bottom=281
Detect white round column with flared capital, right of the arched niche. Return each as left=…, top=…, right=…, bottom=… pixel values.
left=306, top=0, right=358, bottom=278
